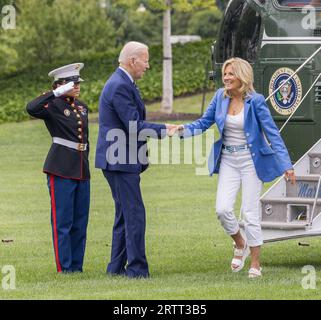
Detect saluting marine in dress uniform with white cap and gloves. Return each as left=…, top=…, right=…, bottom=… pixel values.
left=27, top=63, right=90, bottom=272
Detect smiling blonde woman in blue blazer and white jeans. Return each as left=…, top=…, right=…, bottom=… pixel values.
left=178, top=58, right=295, bottom=278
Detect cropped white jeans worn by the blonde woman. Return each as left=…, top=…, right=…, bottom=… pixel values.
left=216, top=150, right=263, bottom=247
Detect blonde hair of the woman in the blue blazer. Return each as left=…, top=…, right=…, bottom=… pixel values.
left=222, top=58, right=255, bottom=99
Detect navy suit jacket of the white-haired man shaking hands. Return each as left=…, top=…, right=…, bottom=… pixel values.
left=95, top=68, right=166, bottom=173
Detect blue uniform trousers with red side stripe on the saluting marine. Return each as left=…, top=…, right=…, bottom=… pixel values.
left=47, top=174, right=90, bottom=272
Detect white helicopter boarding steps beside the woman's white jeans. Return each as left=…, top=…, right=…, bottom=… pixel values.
left=239, top=139, right=321, bottom=243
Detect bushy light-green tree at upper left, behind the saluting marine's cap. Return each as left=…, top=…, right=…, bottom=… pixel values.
left=0, top=0, right=115, bottom=72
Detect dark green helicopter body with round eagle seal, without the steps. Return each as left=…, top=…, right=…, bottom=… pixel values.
left=211, top=0, right=321, bottom=162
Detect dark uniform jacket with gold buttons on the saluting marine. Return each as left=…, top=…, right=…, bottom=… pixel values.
left=27, top=91, right=90, bottom=180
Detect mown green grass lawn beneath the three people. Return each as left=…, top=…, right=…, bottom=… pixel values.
left=0, top=96, right=321, bottom=300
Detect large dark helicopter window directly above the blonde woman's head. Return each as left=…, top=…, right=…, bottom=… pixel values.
left=218, top=0, right=261, bottom=63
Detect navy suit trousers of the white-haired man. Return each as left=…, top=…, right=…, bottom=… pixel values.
left=102, top=170, right=149, bottom=277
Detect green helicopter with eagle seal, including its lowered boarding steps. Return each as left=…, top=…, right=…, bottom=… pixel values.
left=210, top=0, right=321, bottom=243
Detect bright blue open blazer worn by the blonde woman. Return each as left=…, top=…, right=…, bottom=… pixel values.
left=183, top=88, right=293, bottom=182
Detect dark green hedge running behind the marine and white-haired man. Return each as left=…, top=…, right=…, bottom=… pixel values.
left=0, top=41, right=211, bottom=123
